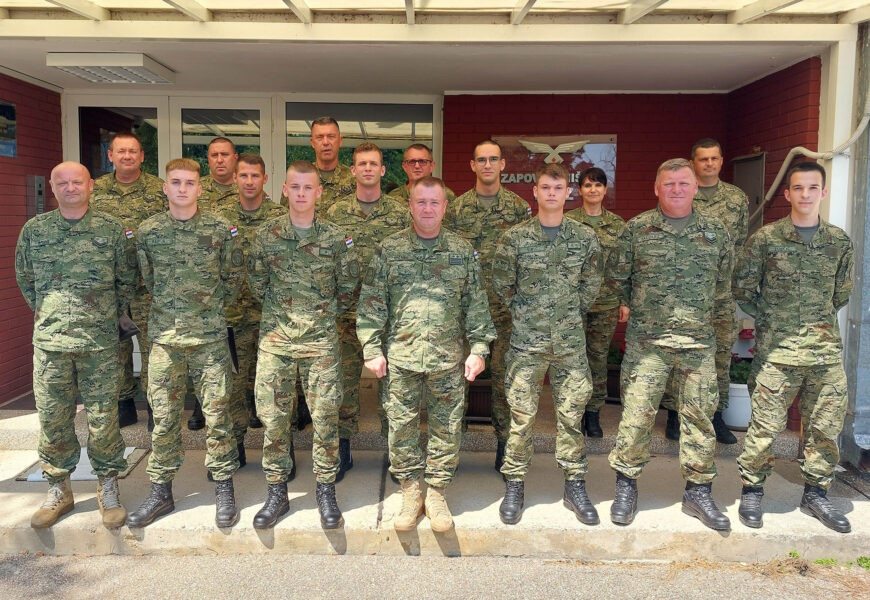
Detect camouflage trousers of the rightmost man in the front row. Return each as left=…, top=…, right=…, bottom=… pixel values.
left=737, top=361, right=847, bottom=489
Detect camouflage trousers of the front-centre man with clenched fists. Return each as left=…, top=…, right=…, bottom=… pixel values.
left=384, top=358, right=465, bottom=487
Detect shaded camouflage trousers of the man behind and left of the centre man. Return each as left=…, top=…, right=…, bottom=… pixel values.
left=338, top=319, right=388, bottom=440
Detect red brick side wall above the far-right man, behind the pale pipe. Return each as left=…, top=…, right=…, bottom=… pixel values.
left=727, top=57, right=822, bottom=223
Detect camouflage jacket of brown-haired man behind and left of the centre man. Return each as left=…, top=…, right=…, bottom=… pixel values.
left=323, top=192, right=411, bottom=321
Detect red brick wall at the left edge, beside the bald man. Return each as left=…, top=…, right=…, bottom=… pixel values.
left=0, top=74, right=62, bottom=402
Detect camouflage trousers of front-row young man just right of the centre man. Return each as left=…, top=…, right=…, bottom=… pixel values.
left=501, top=348, right=592, bottom=481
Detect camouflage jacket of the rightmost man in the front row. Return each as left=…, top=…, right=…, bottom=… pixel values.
left=734, top=216, right=854, bottom=366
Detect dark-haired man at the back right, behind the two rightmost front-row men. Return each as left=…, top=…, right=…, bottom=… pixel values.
left=662, top=138, right=749, bottom=444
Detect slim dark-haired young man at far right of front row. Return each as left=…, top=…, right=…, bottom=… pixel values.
left=734, top=162, right=853, bottom=533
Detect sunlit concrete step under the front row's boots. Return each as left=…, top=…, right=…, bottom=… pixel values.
left=0, top=450, right=870, bottom=564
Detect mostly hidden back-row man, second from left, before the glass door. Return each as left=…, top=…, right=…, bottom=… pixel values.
left=187, top=137, right=244, bottom=428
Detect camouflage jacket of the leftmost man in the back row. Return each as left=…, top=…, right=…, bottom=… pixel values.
left=90, top=172, right=169, bottom=233
